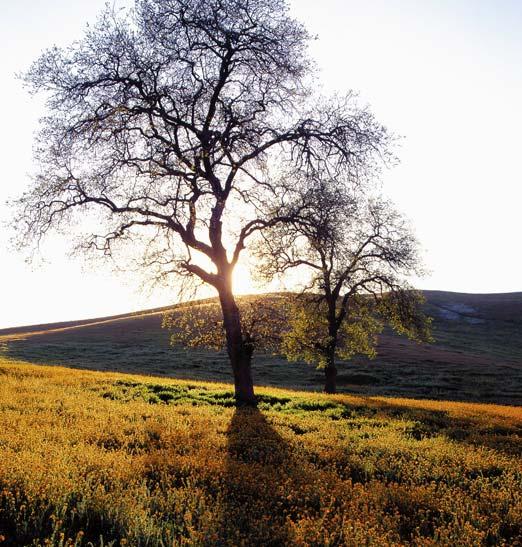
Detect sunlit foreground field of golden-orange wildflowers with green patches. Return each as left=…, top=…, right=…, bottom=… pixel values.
left=0, top=360, right=522, bottom=547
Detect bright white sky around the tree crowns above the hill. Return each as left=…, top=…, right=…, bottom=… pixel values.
left=0, top=0, right=522, bottom=328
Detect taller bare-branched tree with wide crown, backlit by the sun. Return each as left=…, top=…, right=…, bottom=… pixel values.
left=14, top=0, right=390, bottom=402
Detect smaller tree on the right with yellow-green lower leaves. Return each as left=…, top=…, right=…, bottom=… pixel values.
left=256, top=180, right=430, bottom=393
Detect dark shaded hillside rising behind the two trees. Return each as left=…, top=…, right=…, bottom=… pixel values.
left=0, top=291, right=522, bottom=405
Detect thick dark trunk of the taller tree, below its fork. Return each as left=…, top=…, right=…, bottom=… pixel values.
left=219, top=289, right=257, bottom=405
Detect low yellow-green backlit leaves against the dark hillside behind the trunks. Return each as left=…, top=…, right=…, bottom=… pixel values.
left=163, top=293, right=429, bottom=376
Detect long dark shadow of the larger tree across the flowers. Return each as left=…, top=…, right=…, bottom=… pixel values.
left=218, top=407, right=301, bottom=546
